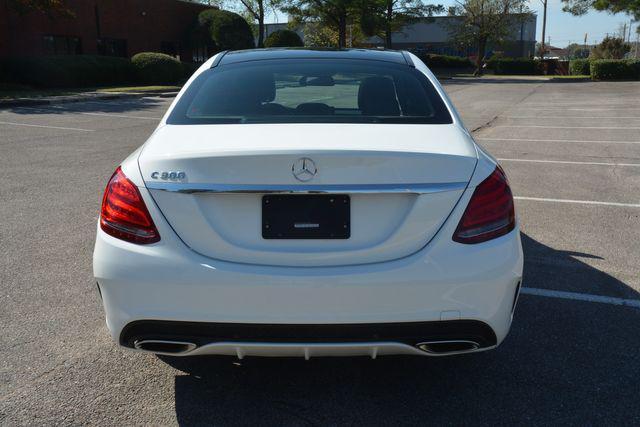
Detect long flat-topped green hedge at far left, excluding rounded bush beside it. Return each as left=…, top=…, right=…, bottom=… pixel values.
left=2, top=55, right=135, bottom=88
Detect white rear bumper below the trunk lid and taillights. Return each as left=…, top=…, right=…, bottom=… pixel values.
left=94, top=187, right=523, bottom=356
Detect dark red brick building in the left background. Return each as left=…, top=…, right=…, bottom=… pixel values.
left=0, top=0, right=215, bottom=62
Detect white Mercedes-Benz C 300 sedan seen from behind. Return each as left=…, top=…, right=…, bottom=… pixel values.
left=93, top=49, right=523, bottom=358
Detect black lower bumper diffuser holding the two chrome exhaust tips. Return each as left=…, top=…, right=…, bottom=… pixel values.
left=120, top=320, right=497, bottom=359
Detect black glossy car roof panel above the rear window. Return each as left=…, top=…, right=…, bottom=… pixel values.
left=213, top=48, right=413, bottom=67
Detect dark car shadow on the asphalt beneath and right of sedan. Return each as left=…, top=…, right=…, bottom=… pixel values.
left=161, top=235, right=640, bottom=425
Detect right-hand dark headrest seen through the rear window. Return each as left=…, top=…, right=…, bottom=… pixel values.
left=358, top=76, right=400, bottom=116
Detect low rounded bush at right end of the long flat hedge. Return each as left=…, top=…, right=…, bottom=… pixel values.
left=131, top=52, right=184, bottom=85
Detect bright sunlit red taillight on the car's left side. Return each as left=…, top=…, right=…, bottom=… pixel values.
left=100, top=167, right=160, bottom=245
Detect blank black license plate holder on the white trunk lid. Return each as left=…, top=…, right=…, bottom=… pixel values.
left=262, top=194, right=351, bottom=239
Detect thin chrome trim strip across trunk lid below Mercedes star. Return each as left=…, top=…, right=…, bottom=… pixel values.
left=146, top=181, right=467, bottom=194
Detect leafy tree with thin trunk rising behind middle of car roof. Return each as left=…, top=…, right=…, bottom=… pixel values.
left=282, top=0, right=358, bottom=48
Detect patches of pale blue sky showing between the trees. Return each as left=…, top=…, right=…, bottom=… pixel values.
left=267, top=0, right=638, bottom=47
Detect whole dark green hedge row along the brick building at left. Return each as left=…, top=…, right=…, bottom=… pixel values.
left=0, top=53, right=195, bottom=88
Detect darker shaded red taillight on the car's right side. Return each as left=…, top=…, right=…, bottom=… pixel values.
left=453, top=166, right=516, bottom=244
